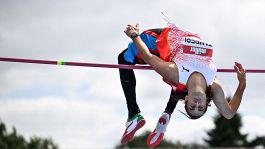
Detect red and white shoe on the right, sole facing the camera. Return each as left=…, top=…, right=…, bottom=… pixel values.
left=147, top=113, right=170, bottom=147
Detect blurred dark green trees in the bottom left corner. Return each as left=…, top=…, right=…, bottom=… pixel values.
left=0, top=120, right=58, bottom=149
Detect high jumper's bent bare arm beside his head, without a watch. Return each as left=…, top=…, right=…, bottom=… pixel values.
left=212, top=63, right=246, bottom=119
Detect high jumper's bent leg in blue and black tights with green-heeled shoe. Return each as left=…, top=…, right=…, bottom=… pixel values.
left=118, top=29, right=161, bottom=144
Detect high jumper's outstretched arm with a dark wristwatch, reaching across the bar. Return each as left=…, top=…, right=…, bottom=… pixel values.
left=124, top=24, right=178, bottom=84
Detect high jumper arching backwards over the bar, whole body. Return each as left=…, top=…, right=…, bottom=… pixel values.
left=118, top=24, right=246, bottom=147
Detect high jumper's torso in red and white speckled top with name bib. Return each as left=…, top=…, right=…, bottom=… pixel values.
left=153, top=28, right=217, bottom=91
